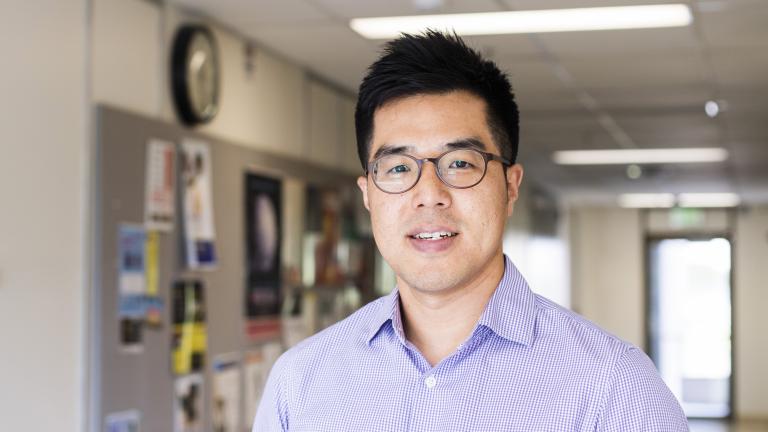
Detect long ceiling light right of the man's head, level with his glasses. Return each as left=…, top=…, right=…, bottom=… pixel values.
left=552, top=148, right=728, bottom=165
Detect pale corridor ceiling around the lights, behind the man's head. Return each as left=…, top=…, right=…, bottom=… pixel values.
left=174, top=0, right=768, bottom=203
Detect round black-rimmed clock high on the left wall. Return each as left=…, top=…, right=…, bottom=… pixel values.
left=171, top=25, right=219, bottom=126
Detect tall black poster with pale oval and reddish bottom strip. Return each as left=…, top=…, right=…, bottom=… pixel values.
left=245, top=173, right=281, bottom=339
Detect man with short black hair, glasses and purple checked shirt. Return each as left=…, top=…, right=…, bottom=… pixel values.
left=253, top=32, right=688, bottom=432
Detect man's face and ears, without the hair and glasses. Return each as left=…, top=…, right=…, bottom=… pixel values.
left=357, top=91, right=522, bottom=293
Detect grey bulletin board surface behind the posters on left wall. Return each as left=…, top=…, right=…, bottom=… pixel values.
left=93, top=106, right=354, bottom=432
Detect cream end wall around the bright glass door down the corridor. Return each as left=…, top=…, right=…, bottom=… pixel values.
left=570, top=207, right=768, bottom=418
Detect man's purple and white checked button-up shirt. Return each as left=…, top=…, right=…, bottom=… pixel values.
left=253, top=257, right=688, bottom=432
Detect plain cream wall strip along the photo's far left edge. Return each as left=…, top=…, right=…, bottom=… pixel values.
left=0, top=0, right=90, bottom=432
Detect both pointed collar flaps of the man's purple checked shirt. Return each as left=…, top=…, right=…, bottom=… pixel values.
left=366, top=255, right=536, bottom=345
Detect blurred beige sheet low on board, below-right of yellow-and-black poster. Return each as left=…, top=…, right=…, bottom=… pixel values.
left=211, top=353, right=240, bottom=432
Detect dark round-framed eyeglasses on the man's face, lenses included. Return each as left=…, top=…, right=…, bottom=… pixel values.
left=365, top=149, right=512, bottom=194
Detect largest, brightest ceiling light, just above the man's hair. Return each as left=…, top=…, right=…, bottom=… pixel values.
left=349, top=3, right=693, bottom=39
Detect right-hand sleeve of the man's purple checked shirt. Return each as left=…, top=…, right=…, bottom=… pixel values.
left=595, top=347, right=688, bottom=432
